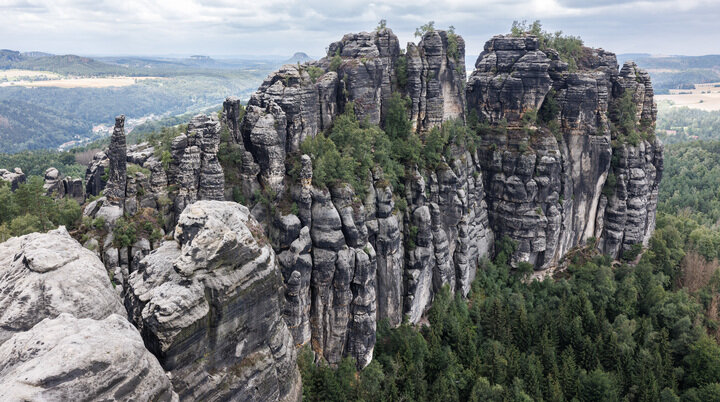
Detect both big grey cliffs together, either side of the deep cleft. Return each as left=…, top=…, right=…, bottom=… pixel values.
left=225, top=29, right=662, bottom=366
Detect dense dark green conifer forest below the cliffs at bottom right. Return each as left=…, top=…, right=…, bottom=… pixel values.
left=299, top=231, right=720, bottom=402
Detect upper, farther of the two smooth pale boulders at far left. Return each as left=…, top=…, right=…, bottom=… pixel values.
left=0, top=227, right=125, bottom=343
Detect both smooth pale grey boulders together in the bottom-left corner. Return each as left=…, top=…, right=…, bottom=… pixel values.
left=0, top=227, right=177, bottom=401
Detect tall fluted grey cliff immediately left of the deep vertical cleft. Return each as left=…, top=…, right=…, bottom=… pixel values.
left=225, top=29, right=484, bottom=366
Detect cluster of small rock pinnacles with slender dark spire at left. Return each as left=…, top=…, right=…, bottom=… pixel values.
left=83, top=115, right=225, bottom=293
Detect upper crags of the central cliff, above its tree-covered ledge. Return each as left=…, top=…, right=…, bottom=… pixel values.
left=240, top=28, right=465, bottom=198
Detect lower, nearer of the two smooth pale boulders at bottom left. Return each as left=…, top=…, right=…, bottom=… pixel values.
left=0, top=313, right=178, bottom=401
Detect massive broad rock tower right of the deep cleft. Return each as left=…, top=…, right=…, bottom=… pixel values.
left=467, top=36, right=662, bottom=269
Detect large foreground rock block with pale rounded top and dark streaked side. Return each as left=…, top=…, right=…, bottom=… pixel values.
left=125, top=201, right=301, bottom=401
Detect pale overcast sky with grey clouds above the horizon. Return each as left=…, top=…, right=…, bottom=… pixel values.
left=0, top=0, right=720, bottom=56
